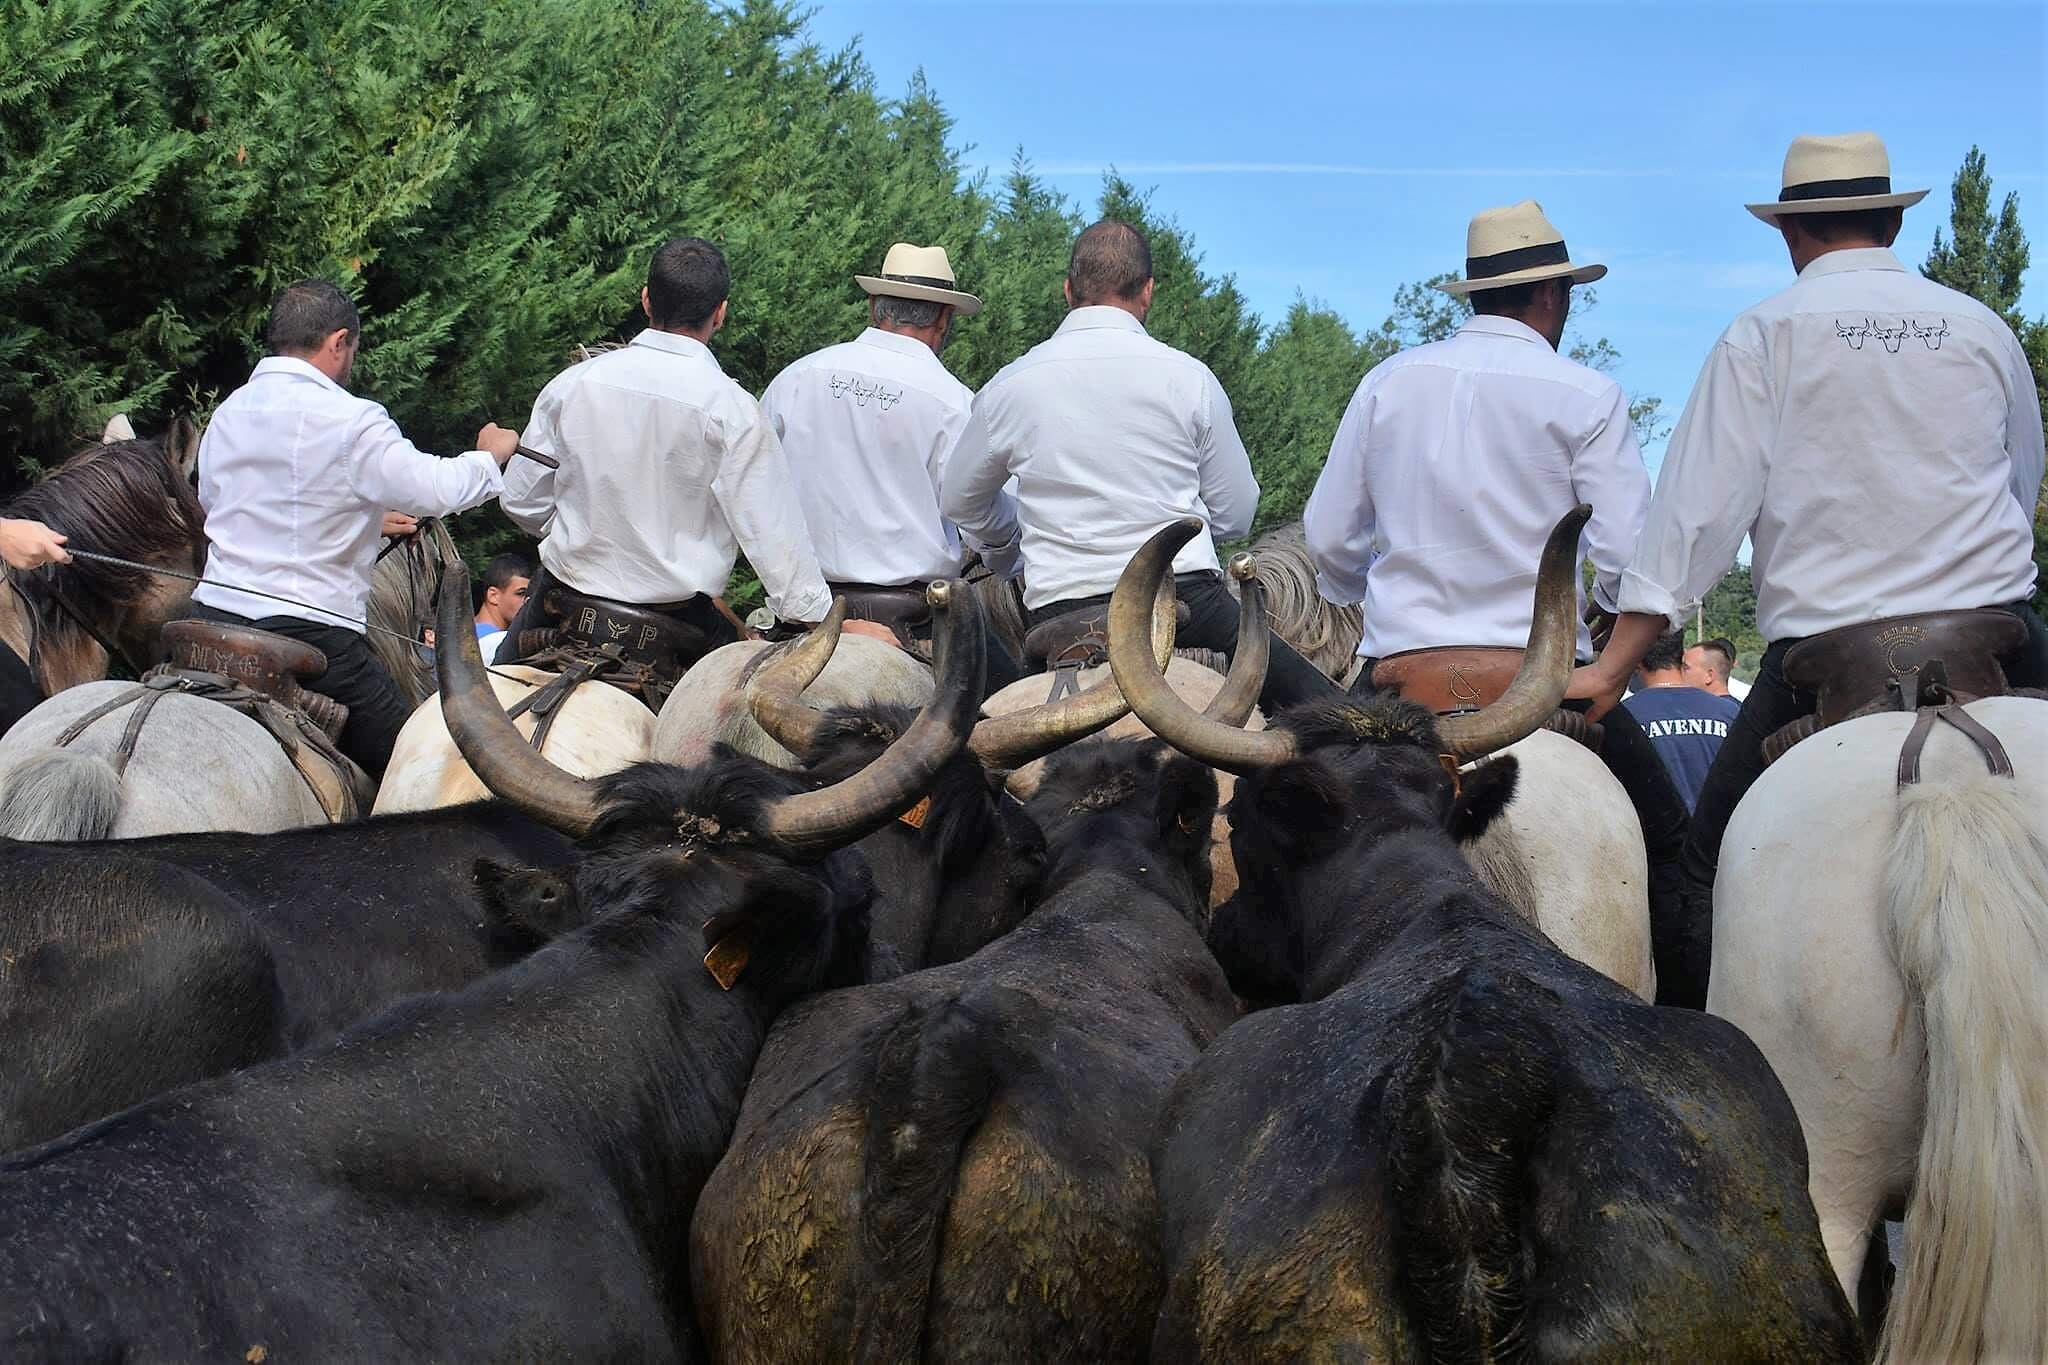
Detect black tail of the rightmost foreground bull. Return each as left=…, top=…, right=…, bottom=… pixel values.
left=1384, top=966, right=1561, bottom=1361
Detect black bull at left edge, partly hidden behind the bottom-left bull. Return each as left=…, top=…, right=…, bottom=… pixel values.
left=0, top=802, right=575, bottom=1150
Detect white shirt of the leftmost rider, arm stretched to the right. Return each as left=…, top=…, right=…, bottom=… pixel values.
left=193, top=356, right=502, bottom=634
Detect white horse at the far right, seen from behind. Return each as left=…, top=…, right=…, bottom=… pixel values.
left=1706, top=698, right=2048, bottom=1361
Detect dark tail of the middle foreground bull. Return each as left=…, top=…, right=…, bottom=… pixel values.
left=854, top=997, right=995, bottom=1363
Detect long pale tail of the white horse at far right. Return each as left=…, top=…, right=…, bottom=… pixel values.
left=1878, top=776, right=2048, bottom=1361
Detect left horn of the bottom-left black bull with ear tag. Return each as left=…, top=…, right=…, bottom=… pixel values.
left=434, top=563, right=598, bottom=837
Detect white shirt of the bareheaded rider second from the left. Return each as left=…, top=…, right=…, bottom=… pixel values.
left=502, top=327, right=831, bottom=620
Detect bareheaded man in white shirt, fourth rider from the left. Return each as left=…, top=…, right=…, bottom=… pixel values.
left=940, top=219, right=1333, bottom=712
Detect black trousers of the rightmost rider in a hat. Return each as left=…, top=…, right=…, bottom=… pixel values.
left=1679, top=602, right=2048, bottom=999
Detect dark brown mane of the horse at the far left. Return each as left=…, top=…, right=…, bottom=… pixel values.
left=6, top=440, right=207, bottom=632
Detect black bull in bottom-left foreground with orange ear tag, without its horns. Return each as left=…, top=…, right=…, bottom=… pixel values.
left=0, top=759, right=868, bottom=1361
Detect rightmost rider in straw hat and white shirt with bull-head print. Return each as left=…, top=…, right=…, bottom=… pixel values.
left=1571, top=133, right=2048, bottom=998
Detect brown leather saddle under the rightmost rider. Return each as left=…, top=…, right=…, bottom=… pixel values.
left=1786, top=608, right=2028, bottom=726
